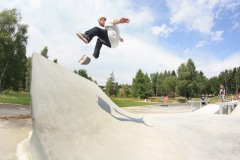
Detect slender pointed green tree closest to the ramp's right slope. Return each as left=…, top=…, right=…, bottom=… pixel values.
left=106, top=72, right=118, bottom=96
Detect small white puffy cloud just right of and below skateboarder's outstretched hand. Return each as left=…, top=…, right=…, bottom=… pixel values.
left=152, top=24, right=173, bottom=38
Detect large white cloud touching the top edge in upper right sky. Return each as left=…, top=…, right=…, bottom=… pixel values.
left=167, top=0, right=218, bottom=34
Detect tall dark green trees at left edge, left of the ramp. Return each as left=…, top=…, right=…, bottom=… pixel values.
left=0, top=9, right=28, bottom=91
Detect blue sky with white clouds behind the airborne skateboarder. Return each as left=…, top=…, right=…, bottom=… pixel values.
left=0, top=0, right=240, bottom=85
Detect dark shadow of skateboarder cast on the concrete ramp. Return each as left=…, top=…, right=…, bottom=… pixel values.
left=97, top=97, right=153, bottom=127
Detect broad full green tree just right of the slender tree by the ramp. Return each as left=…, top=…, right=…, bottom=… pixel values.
left=131, top=69, right=153, bottom=98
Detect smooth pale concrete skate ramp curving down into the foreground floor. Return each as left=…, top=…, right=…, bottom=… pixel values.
left=15, top=53, right=240, bottom=160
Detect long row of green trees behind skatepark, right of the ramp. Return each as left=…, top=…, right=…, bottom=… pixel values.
left=78, top=59, right=240, bottom=99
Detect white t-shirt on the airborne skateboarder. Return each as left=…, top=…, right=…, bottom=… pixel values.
left=105, top=21, right=120, bottom=48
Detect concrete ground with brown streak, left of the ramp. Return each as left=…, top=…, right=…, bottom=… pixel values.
left=0, top=104, right=32, bottom=160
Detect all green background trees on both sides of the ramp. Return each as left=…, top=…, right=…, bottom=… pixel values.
left=0, top=9, right=240, bottom=98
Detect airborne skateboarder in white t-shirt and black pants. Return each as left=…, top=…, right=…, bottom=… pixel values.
left=76, top=17, right=130, bottom=59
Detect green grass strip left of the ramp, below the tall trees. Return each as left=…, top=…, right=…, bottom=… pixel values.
left=0, top=90, right=30, bottom=105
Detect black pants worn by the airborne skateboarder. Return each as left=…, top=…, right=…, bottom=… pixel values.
left=85, top=27, right=111, bottom=57
